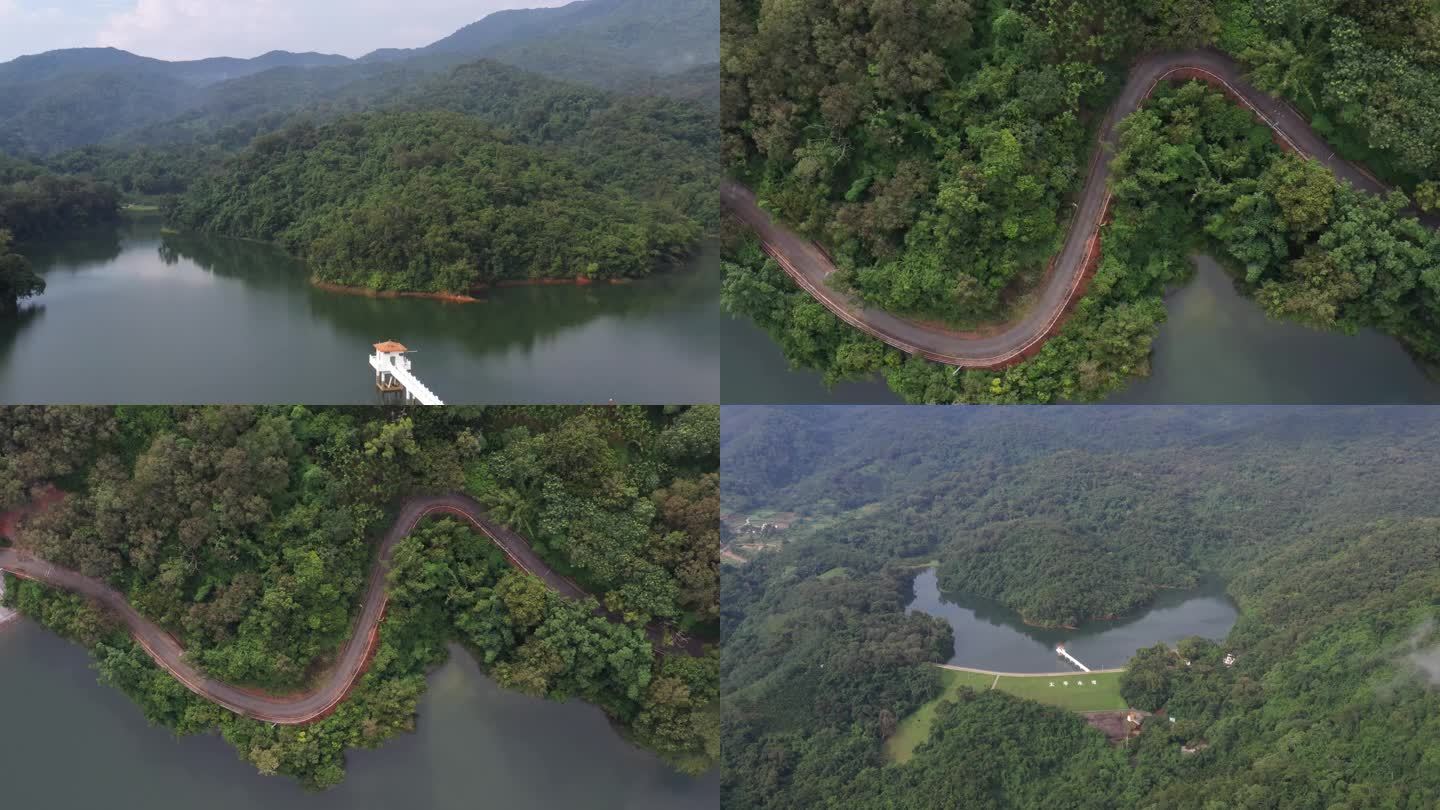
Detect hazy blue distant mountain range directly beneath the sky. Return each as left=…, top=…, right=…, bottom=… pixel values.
left=0, top=0, right=720, bottom=156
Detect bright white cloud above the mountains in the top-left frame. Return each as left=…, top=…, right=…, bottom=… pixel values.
left=87, top=0, right=567, bottom=59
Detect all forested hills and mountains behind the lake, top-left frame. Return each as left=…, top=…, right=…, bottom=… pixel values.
left=0, top=0, right=720, bottom=293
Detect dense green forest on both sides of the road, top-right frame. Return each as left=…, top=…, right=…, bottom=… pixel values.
left=721, top=0, right=1440, bottom=402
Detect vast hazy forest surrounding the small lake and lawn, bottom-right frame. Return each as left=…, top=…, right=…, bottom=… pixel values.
left=721, top=406, right=1440, bottom=809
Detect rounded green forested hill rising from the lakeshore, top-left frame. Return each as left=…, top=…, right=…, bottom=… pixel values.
left=173, top=112, right=700, bottom=293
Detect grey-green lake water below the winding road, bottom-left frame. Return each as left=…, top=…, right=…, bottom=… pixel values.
left=0, top=620, right=720, bottom=810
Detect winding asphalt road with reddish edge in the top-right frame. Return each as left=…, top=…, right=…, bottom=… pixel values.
left=731, top=50, right=1436, bottom=369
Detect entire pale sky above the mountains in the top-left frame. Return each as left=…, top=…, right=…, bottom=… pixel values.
left=0, top=0, right=569, bottom=62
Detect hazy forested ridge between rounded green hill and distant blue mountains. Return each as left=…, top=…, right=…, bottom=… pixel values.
left=45, top=61, right=720, bottom=229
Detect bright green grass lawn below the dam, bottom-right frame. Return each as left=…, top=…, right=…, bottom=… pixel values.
left=886, top=669, right=1128, bottom=762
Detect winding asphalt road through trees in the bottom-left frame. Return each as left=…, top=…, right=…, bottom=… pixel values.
left=0, top=494, right=704, bottom=725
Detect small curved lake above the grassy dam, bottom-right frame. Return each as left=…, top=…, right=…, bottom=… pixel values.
left=907, top=568, right=1240, bottom=673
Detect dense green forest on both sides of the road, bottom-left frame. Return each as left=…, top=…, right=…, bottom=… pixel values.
left=0, top=406, right=719, bottom=787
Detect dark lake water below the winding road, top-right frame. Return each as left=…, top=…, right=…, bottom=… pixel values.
left=723, top=257, right=1440, bottom=405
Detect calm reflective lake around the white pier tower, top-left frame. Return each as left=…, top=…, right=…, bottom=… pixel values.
left=0, top=222, right=723, bottom=405
